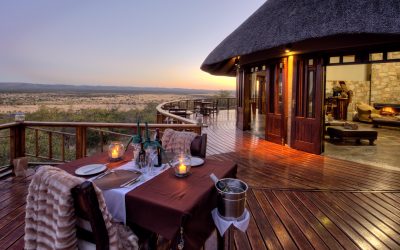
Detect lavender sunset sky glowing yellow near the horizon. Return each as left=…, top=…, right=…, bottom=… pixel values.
left=0, top=0, right=264, bottom=90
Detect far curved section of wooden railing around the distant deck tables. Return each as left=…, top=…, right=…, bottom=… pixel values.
left=157, top=97, right=236, bottom=126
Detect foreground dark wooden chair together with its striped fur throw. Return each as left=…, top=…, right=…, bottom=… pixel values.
left=24, top=166, right=139, bottom=249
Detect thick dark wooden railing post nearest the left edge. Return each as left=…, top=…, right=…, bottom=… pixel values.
left=10, top=123, right=25, bottom=165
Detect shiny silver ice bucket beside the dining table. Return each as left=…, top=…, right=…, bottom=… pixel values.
left=215, top=178, right=248, bottom=220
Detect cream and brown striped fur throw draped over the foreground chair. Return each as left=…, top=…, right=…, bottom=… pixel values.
left=24, top=166, right=139, bottom=249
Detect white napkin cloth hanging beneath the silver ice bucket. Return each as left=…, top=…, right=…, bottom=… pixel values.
left=211, top=208, right=250, bottom=236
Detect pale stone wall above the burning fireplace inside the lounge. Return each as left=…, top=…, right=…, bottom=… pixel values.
left=371, top=62, right=400, bottom=103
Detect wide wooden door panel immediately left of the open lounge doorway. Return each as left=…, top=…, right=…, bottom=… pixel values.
left=291, top=58, right=324, bottom=154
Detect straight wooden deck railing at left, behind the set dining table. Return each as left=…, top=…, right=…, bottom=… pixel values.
left=0, top=121, right=201, bottom=175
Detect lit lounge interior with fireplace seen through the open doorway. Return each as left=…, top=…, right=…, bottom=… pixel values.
left=324, top=59, right=400, bottom=170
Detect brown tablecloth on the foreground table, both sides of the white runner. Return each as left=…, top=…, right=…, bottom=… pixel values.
left=59, top=150, right=237, bottom=249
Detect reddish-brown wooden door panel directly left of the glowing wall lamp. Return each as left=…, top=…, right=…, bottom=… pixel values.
left=265, top=59, right=287, bottom=145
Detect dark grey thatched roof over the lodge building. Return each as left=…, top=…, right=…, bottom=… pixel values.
left=201, top=0, right=400, bottom=74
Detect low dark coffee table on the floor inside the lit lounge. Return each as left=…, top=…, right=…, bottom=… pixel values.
left=327, top=126, right=378, bottom=145
